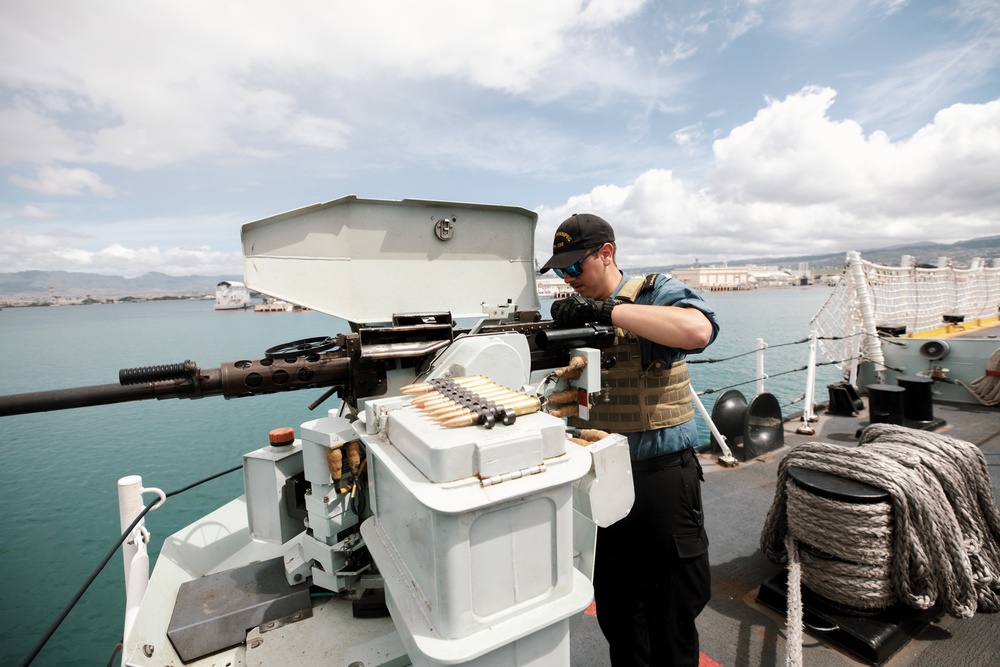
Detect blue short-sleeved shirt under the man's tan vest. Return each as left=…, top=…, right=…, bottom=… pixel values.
left=611, top=275, right=719, bottom=461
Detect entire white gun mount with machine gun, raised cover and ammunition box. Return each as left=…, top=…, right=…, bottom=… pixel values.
left=0, top=197, right=632, bottom=667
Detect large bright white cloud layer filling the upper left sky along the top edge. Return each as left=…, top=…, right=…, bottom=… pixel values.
left=0, top=0, right=645, bottom=169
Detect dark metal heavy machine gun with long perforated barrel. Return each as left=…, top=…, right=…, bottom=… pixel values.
left=0, top=311, right=614, bottom=417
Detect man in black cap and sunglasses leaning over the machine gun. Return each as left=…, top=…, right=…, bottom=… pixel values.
left=541, top=213, right=719, bottom=667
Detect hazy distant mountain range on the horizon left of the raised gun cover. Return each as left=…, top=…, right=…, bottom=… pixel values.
left=0, top=271, right=243, bottom=300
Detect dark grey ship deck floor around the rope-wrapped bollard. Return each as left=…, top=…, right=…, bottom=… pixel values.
left=572, top=396, right=1000, bottom=667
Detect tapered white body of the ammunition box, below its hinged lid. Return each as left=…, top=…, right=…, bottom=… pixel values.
left=362, top=420, right=593, bottom=667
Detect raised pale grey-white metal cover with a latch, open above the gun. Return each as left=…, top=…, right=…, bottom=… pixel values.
left=242, top=196, right=539, bottom=324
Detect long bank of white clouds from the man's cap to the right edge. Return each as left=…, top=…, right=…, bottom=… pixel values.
left=538, top=88, right=1000, bottom=266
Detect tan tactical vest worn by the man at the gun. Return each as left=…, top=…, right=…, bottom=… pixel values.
left=569, top=274, right=694, bottom=433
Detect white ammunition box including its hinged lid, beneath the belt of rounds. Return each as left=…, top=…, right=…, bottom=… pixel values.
left=361, top=399, right=593, bottom=667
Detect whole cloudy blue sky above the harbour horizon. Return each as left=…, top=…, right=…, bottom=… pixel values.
left=0, top=0, right=1000, bottom=277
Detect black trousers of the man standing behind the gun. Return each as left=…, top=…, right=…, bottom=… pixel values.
left=594, top=449, right=711, bottom=667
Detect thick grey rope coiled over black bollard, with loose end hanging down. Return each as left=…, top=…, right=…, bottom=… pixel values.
left=760, top=424, right=1000, bottom=665
